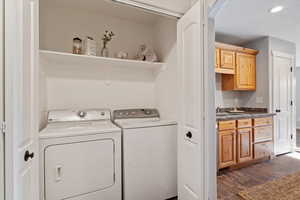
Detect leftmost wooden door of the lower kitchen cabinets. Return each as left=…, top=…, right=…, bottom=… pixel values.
left=219, top=130, right=236, bottom=169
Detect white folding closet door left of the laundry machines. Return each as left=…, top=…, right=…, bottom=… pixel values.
left=5, top=0, right=38, bottom=200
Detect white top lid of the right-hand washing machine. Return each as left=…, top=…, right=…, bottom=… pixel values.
left=115, top=118, right=177, bottom=129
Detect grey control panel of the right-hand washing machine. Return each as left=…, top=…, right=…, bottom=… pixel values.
left=113, top=108, right=159, bottom=119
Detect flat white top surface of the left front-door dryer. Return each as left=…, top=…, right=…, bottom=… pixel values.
left=39, top=120, right=121, bottom=139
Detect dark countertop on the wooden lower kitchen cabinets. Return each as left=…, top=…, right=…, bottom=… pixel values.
left=216, top=112, right=276, bottom=121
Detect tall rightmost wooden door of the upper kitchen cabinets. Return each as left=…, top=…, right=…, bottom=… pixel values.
left=236, top=53, right=256, bottom=90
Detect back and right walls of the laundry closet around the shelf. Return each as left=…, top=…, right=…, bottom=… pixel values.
left=40, top=1, right=177, bottom=128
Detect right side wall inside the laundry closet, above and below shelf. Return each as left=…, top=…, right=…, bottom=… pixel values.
left=155, top=19, right=178, bottom=120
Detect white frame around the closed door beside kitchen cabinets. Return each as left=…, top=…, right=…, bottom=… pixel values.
left=269, top=50, right=296, bottom=155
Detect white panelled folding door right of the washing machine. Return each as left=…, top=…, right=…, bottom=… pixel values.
left=177, top=1, right=204, bottom=200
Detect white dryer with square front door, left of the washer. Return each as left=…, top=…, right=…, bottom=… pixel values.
left=39, top=110, right=122, bottom=200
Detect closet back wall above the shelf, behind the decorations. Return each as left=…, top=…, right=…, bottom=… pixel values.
left=40, top=1, right=154, bottom=58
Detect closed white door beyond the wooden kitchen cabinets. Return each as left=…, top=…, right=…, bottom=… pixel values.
left=273, top=52, right=294, bottom=155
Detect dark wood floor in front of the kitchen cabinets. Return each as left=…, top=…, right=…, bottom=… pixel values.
left=218, top=153, right=300, bottom=200
